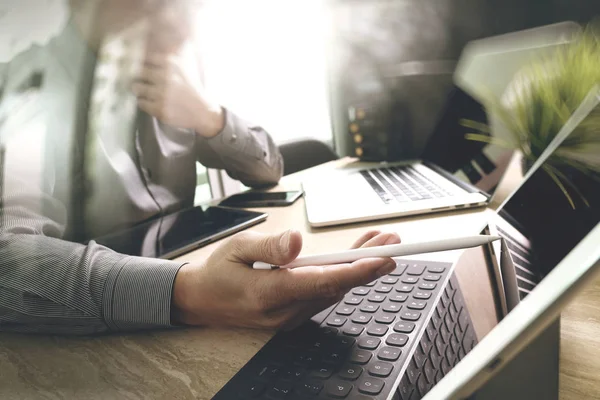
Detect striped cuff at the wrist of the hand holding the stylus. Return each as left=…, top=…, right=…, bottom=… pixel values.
left=102, top=257, right=185, bottom=331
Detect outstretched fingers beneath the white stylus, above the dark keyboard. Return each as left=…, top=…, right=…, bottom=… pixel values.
left=278, top=258, right=396, bottom=303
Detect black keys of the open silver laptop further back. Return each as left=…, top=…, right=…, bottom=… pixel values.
left=360, top=165, right=452, bottom=204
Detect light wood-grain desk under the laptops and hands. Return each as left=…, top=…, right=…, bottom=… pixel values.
left=0, top=160, right=600, bottom=400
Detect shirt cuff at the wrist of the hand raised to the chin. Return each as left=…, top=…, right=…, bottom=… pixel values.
left=206, top=108, right=266, bottom=160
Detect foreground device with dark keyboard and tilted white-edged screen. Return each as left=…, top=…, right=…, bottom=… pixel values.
left=214, top=86, right=600, bottom=400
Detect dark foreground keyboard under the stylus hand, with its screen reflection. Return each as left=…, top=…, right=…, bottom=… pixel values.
left=214, top=261, right=475, bottom=400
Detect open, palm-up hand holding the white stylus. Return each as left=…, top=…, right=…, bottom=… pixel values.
left=172, top=231, right=400, bottom=329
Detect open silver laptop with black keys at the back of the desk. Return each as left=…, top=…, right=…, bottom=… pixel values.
left=302, top=23, right=580, bottom=227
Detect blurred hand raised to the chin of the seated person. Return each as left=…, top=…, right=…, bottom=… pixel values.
left=131, top=54, right=225, bottom=138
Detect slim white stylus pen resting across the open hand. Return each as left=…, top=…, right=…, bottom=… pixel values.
left=252, top=235, right=501, bottom=269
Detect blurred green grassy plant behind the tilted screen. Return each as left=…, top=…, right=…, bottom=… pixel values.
left=462, top=23, right=600, bottom=207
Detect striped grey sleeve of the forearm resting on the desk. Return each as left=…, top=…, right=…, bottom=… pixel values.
left=0, top=174, right=183, bottom=335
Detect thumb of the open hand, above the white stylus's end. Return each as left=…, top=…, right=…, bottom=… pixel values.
left=230, top=230, right=302, bottom=265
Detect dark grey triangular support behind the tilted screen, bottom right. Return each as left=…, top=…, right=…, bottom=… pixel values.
left=469, top=319, right=560, bottom=400
